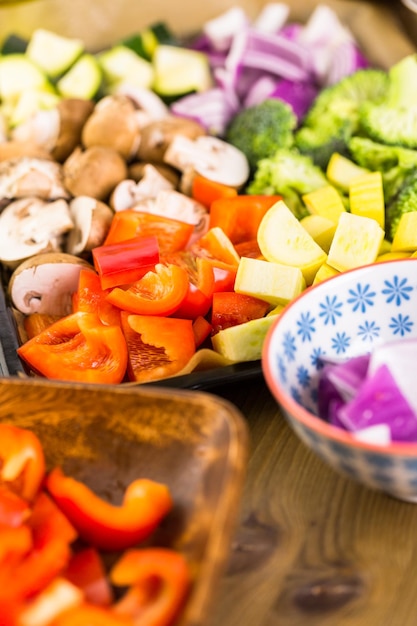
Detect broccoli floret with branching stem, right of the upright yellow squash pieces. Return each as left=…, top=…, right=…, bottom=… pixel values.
left=348, top=137, right=417, bottom=203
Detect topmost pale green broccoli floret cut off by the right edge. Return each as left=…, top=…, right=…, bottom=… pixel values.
left=360, top=54, right=417, bottom=148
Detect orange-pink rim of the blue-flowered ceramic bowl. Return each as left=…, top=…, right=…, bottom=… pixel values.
left=261, top=257, right=417, bottom=457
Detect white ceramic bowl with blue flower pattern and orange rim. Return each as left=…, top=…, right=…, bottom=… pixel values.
left=262, top=259, right=417, bottom=502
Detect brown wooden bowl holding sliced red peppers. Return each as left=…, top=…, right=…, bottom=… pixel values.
left=0, top=378, right=248, bottom=626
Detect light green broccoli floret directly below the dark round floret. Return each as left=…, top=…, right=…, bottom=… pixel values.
left=246, top=148, right=329, bottom=219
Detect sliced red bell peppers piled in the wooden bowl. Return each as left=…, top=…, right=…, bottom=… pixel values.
left=0, top=424, right=188, bottom=626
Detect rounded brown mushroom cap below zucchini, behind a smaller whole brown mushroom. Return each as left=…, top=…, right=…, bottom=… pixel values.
left=81, top=94, right=140, bottom=161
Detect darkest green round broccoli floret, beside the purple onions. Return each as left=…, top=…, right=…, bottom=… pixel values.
left=225, top=99, right=297, bottom=171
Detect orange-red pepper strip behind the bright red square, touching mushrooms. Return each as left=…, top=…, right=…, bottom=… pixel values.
left=104, top=209, right=194, bottom=253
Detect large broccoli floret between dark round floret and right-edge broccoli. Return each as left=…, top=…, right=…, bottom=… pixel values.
left=295, top=68, right=388, bottom=170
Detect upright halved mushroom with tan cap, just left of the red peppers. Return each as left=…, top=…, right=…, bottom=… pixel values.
left=65, top=196, right=114, bottom=255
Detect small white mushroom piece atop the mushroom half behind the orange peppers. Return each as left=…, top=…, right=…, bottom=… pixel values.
left=110, top=164, right=174, bottom=211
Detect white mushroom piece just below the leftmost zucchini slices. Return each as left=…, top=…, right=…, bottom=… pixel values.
left=11, top=108, right=61, bottom=152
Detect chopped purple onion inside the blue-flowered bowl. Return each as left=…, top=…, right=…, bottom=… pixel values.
left=318, top=339, right=417, bottom=445
